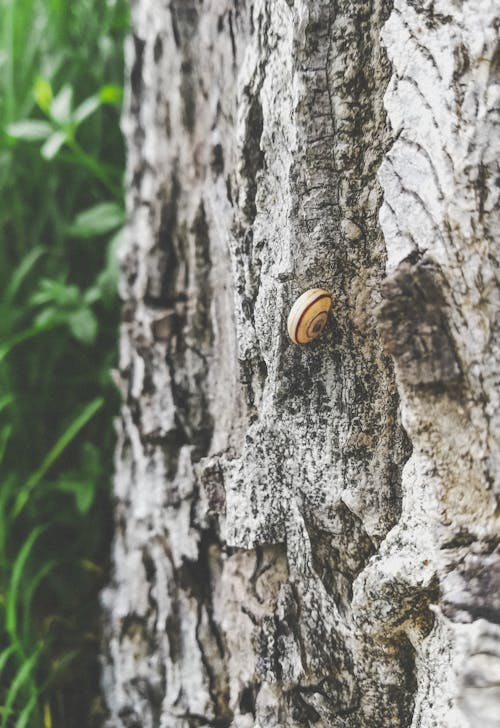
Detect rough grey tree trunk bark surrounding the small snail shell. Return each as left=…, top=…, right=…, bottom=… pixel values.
left=103, top=0, right=500, bottom=728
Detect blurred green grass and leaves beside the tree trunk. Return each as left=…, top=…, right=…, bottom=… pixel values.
left=0, top=0, right=128, bottom=728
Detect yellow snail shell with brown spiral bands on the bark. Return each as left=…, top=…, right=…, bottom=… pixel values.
left=288, top=288, right=332, bottom=344
